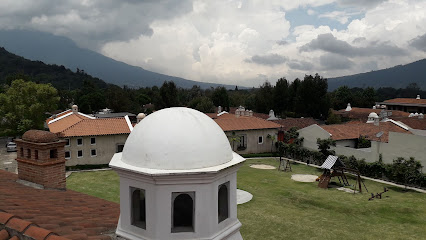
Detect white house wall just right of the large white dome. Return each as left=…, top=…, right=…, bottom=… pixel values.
left=225, top=129, right=278, bottom=154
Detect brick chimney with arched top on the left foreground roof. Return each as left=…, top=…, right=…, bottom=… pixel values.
left=15, top=130, right=66, bottom=190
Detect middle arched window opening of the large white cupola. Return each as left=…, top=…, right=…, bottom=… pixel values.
left=172, top=192, right=195, bottom=233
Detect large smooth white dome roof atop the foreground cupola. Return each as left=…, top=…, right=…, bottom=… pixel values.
left=121, top=107, right=233, bottom=170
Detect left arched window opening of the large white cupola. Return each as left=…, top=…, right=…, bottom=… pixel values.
left=130, top=187, right=146, bottom=229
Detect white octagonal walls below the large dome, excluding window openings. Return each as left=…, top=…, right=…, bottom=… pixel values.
left=117, top=166, right=242, bottom=240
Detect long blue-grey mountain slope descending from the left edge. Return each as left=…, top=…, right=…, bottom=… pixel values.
left=0, top=30, right=240, bottom=89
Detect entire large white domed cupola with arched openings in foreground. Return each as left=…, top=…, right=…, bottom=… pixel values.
left=110, top=107, right=244, bottom=240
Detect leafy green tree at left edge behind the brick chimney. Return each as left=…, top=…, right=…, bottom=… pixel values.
left=0, top=79, right=60, bottom=135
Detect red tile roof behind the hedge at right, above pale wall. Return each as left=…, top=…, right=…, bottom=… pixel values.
left=320, top=122, right=412, bottom=142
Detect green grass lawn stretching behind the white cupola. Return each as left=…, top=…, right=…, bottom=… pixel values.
left=67, top=159, right=426, bottom=240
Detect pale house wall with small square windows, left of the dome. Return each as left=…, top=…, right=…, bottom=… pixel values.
left=63, top=134, right=129, bottom=166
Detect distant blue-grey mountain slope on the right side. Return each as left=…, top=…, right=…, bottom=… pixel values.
left=328, top=59, right=426, bottom=91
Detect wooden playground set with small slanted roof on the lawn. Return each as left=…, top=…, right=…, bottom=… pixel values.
left=318, top=155, right=368, bottom=193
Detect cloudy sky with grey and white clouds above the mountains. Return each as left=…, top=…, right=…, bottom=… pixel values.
left=0, top=0, right=426, bottom=86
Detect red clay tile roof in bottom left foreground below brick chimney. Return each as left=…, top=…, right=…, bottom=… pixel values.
left=0, top=170, right=120, bottom=240
